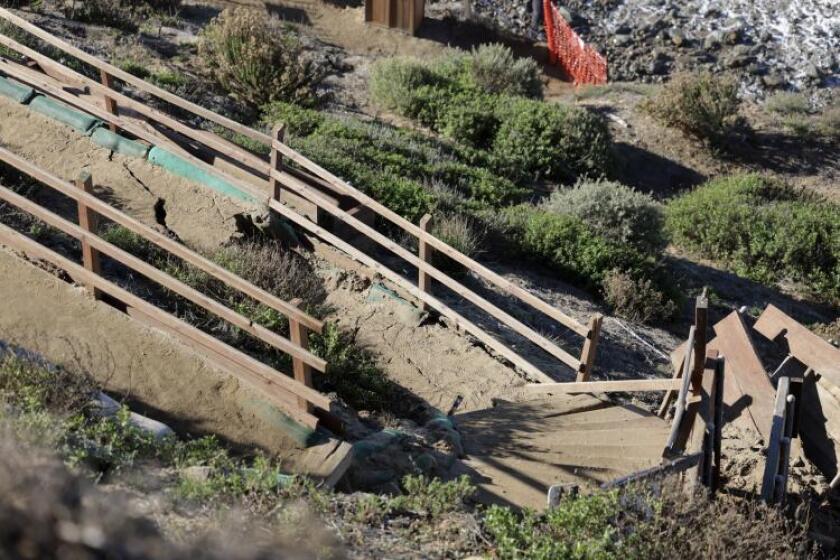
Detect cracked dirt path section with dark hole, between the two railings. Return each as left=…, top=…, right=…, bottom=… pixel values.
left=0, top=97, right=248, bottom=250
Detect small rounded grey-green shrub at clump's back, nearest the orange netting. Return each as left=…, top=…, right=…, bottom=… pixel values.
left=466, top=43, right=542, bottom=99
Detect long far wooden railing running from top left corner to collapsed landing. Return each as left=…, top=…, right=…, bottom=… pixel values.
left=0, top=9, right=602, bottom=382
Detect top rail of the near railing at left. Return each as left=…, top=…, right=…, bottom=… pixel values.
left=0, top=147, right=324, bottom=333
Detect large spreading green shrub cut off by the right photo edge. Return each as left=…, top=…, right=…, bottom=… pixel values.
left=666, top=174, right=840, bottom=301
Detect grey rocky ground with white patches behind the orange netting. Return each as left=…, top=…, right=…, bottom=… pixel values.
left=466, top=0, right=840, bottom=95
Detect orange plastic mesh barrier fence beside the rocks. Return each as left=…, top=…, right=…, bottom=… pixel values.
left=543, top=0, right=607, bottom=85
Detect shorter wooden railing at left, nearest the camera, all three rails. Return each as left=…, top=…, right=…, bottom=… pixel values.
left=0, top=148, right=334, bottom=429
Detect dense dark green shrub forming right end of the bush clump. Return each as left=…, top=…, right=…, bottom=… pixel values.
left=493, top=98, right=611, bottom=180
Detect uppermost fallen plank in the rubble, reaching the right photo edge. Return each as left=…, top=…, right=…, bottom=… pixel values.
left=753, top=305, right=840, bottom=387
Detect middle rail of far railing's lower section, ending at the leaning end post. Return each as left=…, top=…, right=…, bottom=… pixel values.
left=278, top=174, right=580, bottom=371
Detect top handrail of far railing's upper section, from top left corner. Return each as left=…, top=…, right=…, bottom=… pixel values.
left=0, top=8, right=271, bottom=146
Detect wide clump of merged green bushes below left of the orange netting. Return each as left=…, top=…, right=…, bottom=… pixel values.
left=370, top=52, right=611, bottom=181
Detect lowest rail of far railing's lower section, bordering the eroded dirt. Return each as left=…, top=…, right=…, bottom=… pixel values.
left=269, top=195, right=554, bottom=383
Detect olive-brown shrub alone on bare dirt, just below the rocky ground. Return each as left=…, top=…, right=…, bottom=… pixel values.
left=643, top=72, right=741, bottom=146
